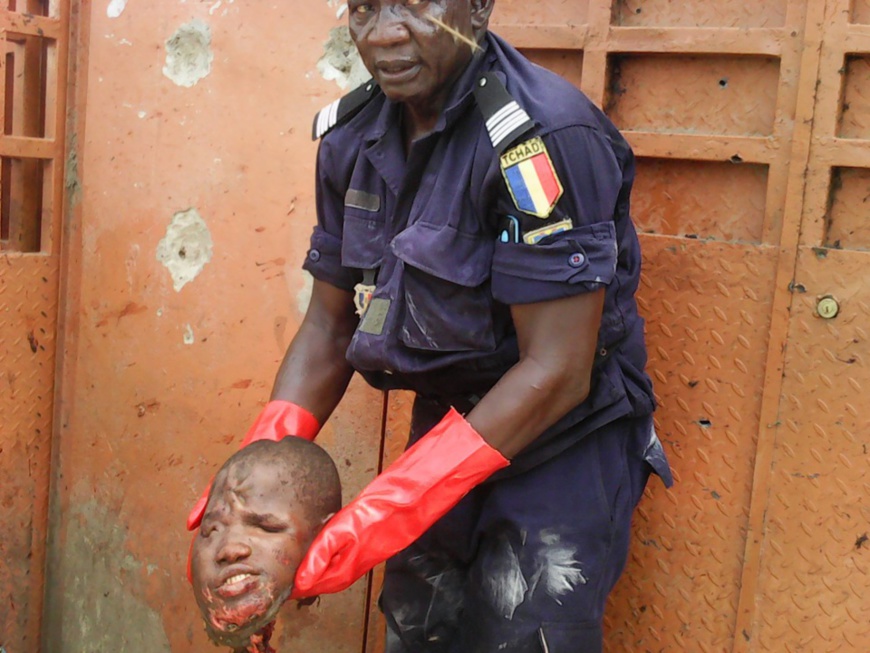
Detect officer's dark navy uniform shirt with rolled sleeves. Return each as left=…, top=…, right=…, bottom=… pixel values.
left=303, top=33, right=668, bottom=473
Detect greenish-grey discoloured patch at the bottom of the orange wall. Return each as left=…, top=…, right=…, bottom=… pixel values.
left=47, top=501, right=172, bottom=653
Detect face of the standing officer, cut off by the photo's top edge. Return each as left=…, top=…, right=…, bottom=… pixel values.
left=348, top=0, right=488, bottom=111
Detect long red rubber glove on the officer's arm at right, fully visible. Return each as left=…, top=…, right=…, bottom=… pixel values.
left=291, top=408, right=510, bottom=599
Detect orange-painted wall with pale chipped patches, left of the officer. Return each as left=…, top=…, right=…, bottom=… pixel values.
left=41, top=0, right=381, bottom=653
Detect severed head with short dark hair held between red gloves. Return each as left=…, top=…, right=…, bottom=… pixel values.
left=191, top=438, right=341, bottom=645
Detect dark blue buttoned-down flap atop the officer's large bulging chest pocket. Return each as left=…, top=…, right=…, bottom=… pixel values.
left=391, top=222, right=495, bottom=288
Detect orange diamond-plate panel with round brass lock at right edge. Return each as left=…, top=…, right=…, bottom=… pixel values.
left=757, top=248, right=870, bottom=653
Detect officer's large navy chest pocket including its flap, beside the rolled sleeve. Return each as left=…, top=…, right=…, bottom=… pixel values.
left=391, top=222, right=496, bottom=352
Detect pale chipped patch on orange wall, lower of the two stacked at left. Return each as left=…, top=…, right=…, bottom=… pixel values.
left=157, top=209, right=213, bottom=292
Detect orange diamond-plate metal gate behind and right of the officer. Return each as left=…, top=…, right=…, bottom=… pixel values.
left=368, top=0, right=870, bottom=653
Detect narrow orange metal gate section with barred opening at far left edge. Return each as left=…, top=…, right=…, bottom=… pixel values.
left=0, top=0, right=68, bottom=653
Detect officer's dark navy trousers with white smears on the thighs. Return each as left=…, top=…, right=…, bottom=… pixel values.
left=379, top=400, right=652, bottom=653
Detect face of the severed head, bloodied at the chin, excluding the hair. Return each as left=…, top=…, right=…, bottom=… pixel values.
left=191, top=463, right=316, bottom=633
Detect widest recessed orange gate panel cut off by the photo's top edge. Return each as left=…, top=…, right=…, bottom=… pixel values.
left=613, top=0, right=788, bottom=29
